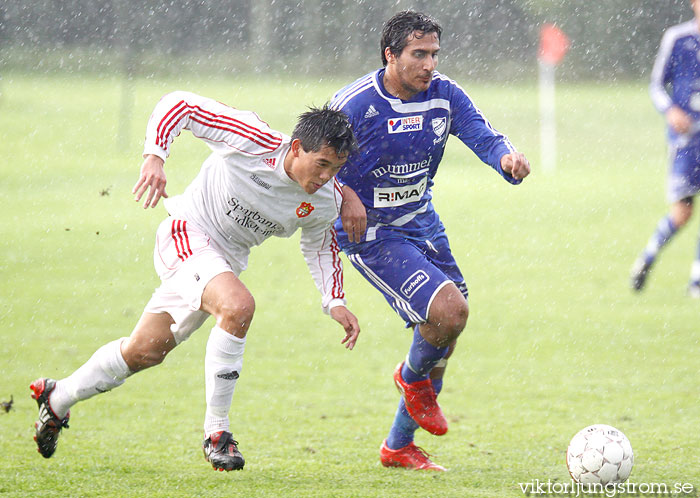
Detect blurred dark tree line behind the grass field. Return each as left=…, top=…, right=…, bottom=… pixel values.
left=0, top=0, right=692, bottom=81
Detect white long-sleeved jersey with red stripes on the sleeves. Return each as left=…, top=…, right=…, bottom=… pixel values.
left=144, top=91, right=345, bottom=312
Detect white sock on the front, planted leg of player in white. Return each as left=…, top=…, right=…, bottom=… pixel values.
left=204, top=326, right=245, bottom=437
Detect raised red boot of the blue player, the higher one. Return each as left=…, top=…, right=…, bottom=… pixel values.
left=394, top=362, right=447, bottom=436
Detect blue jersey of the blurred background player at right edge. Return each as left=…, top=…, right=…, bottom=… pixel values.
left=649, top=20, right=700, bottom=146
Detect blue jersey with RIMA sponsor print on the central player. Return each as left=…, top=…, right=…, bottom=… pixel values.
left=331, top=69, right=520, bottom=253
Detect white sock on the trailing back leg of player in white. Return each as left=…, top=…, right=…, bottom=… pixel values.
left=51, top=337, right=132, bottom=418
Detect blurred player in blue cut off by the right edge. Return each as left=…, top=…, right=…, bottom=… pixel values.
left=631, top=0, right=700, bottom=298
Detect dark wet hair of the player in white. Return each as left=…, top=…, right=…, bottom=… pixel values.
left=292, top=103, right=358, bottom=156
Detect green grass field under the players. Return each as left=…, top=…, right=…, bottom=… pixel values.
left=0, top=75, right=700, bottom=498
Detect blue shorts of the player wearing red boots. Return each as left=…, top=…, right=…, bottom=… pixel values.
left=348, top=231, right=468, bottom=327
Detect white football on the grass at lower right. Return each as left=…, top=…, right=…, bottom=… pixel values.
left=566, top=424, right=634, bottom=486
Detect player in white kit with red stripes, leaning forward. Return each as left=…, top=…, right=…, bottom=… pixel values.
left=30, top=92, right=360, bottom=470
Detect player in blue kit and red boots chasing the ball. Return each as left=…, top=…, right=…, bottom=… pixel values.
left=331, top=11, right=530, bottom=471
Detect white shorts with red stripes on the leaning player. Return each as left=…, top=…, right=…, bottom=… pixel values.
left=144, top=217, right=235, bottom=344
